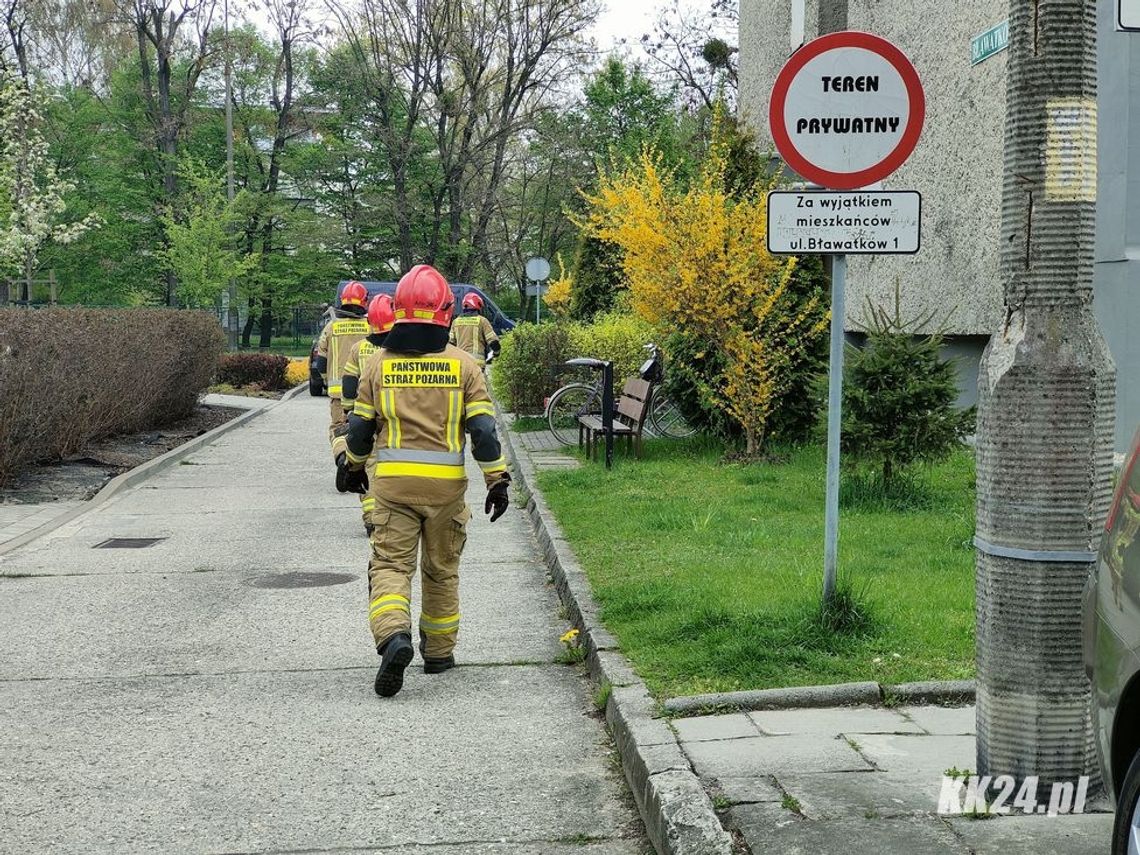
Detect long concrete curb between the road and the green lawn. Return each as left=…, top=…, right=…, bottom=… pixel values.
left=496, top=408, right=733, bottom=855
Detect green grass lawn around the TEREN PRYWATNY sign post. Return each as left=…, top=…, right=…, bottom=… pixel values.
left=539, top=439, right=974, bottom=699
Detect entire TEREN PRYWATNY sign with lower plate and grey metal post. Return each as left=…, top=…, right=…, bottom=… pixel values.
left=767, top=32, right=926, bottom=603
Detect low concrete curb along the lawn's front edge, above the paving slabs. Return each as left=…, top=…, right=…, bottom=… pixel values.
left=663, top=679, right=975, bottom=716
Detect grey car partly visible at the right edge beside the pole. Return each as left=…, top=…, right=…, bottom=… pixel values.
left=1084, top=432, right=1140, bottom=855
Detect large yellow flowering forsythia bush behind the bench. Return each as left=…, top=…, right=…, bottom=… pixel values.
left=578, top=120, right=828, bottom=455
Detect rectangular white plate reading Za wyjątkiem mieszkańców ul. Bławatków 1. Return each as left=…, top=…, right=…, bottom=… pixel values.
left=768, top=190, right=922, bottom=255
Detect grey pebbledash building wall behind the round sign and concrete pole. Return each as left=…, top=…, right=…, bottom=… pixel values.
left=740, top=0, right=1140, bottom=450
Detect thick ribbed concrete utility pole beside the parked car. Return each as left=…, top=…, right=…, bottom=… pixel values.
left=976, top=0, right=1115, bottom=788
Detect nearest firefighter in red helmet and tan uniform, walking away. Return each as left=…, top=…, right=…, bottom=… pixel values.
left=337, top=264, right=511, bottom=697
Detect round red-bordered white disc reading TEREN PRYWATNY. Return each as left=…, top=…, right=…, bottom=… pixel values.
left=768, top=32, right=926, bottom=190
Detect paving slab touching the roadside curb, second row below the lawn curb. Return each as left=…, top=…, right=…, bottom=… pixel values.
left=682, top=736, right=872, bottom=780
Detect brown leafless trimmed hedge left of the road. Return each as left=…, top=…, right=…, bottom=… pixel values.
left=0, top=308, right=225, bottom=485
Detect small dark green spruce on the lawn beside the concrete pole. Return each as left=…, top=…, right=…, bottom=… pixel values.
left=842, top=294, right=975, bottom=486
